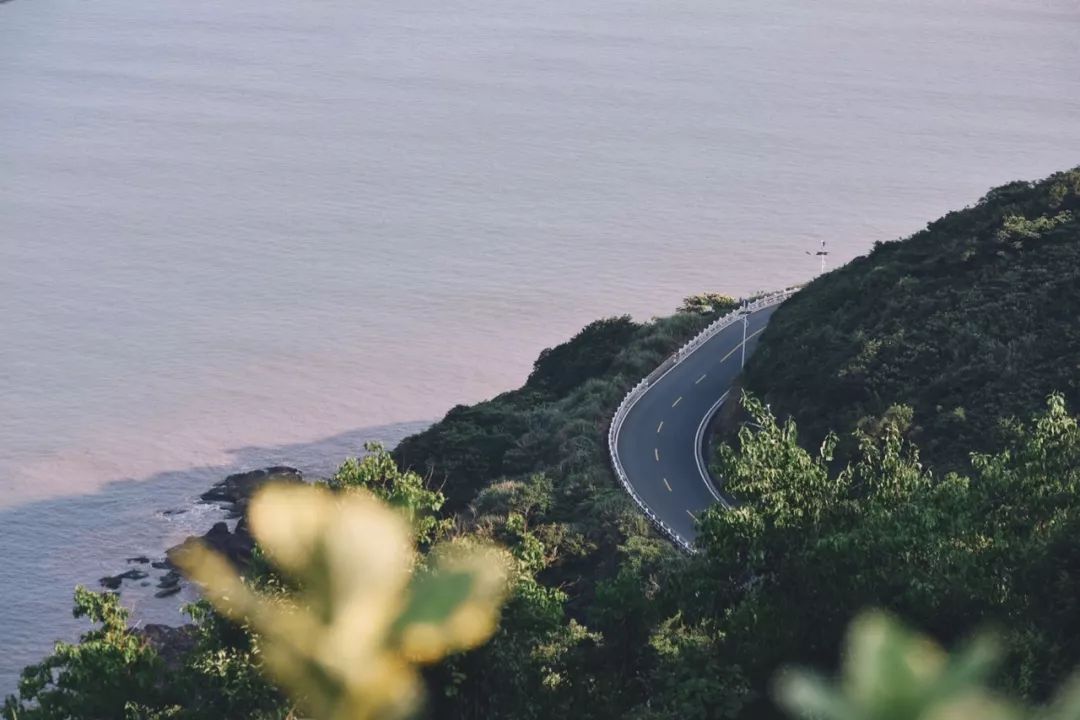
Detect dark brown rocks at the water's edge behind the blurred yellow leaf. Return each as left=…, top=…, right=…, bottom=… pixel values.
left=98, top=465, right=303, bottom=600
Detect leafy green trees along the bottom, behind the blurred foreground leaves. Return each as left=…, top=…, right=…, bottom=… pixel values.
left=12, top=396, right=1080, bottom=720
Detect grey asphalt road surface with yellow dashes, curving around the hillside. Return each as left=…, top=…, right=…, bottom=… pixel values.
left=615, top=303, right=780, bottom=542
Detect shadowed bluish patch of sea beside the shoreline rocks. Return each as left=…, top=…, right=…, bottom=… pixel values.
left=0, top=420, right=432, bottom=696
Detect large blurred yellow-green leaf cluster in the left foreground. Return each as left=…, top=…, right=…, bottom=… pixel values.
left=180, top=486, right=510, bottom=720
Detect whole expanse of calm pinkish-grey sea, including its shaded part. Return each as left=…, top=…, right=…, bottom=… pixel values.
left=0, top=0, right=1080, bottom=692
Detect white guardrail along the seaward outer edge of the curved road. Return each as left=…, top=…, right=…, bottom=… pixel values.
left=608, top=287, right=799, bottom=554
